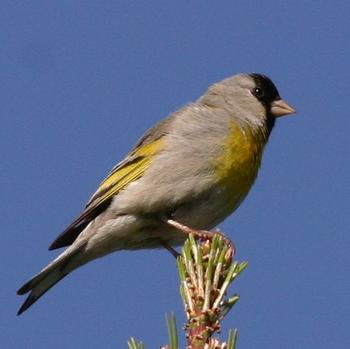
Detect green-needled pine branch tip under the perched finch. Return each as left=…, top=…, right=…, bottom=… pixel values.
left=128, top=233, right=247, bottom=349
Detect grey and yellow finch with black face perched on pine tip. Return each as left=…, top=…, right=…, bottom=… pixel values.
left=17, top=73, right=296, bottom=315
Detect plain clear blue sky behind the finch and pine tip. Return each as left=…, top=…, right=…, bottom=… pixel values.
left=0, top=0, right=350, bottom=349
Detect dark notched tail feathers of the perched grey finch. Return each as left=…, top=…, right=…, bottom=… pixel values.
left=17, top=245, right=85, bottom=315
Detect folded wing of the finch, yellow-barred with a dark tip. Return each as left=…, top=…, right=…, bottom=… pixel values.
left=49, top=131, right=166, bottom=250
